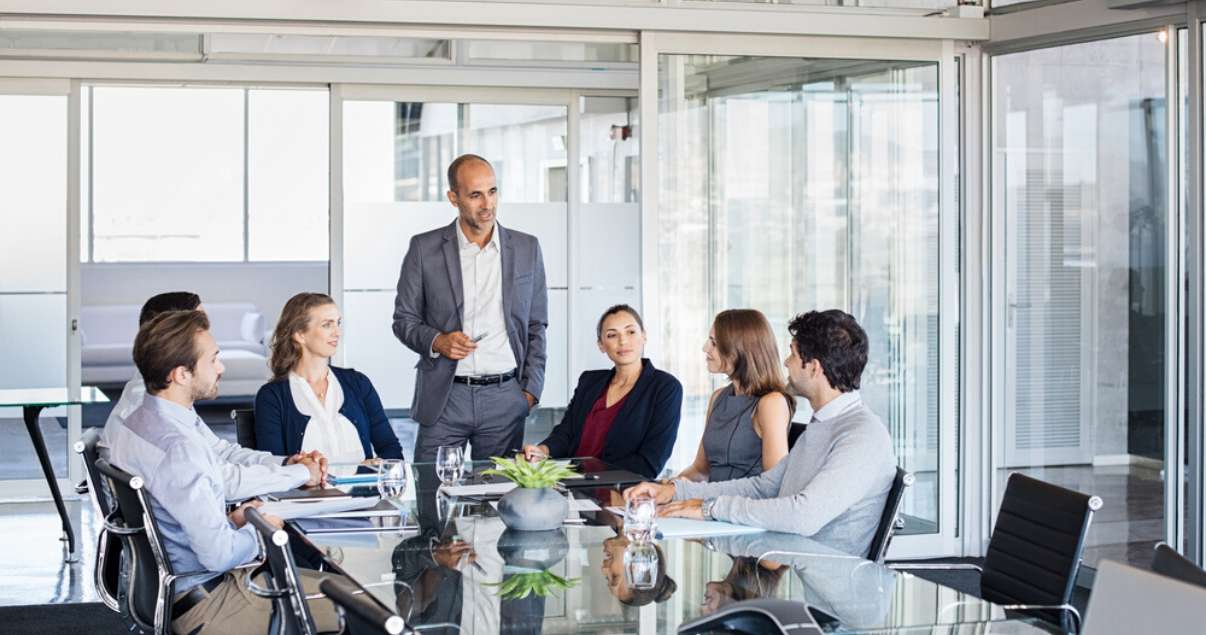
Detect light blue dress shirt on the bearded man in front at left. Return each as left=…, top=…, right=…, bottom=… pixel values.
left=109, top=395, right=259, bottom=593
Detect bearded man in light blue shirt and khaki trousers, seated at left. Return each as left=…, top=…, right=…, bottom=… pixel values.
left=109, top=311, right=339, bottom=635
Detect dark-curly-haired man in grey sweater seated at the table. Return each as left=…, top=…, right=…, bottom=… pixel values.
left=625, top=310, right=896, bottom=557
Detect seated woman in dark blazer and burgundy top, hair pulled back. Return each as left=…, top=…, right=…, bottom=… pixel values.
left=523, top=305, right=683, bottom=478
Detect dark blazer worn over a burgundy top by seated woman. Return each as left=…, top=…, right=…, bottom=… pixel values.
left=540, top=359, right=683, bottom=478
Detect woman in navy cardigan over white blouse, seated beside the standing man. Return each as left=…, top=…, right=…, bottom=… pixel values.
left=256, top=293, right=403, bottom=463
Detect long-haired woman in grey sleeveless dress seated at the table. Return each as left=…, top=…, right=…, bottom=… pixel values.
left=675, top=308, right=796, bottom=482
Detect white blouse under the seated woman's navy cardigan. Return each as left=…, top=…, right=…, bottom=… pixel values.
left=289, top=368, right=367, bottom=463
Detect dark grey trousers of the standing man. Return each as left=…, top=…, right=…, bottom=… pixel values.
left=414, top=380, right=528, bottom=463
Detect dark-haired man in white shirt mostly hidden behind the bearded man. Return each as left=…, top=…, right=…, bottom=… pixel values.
left=100, top=292, right=326, bottom=501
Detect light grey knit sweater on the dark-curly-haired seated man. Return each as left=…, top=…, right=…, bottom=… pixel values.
left=674, top=401, right=896, bottom=557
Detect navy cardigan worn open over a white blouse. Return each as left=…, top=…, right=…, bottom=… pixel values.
left=256, top=366, right=402, bottom=459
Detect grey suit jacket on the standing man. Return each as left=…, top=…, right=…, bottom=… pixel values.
left=393, top=221, right=549, bottom=425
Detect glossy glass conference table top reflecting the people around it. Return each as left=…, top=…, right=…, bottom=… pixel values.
left=293, top=464, right=1064, bottom=635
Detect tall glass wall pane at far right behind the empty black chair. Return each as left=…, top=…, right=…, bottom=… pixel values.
left=993, top=33, right=1177, bottom=566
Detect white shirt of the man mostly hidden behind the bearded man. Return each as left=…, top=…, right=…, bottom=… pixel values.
left=99, top=372, right=310, bottom=502
